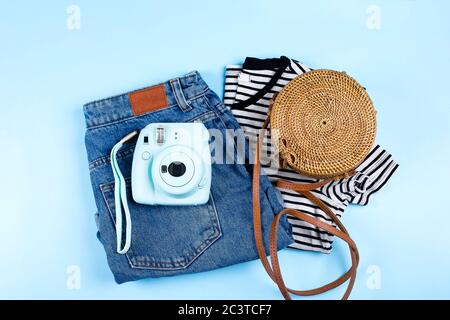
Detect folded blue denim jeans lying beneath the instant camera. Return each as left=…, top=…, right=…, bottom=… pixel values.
left=84, top=72, right=293, bottom=283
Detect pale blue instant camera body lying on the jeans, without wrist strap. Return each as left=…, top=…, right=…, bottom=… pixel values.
left=131, top=122, right=211, bottom=205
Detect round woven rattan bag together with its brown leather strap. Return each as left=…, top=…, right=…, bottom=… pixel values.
left=252, top=70, right=376, bottom=299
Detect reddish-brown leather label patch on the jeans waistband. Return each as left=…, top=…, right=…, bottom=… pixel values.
left=128, top=84, right=168, bottom=116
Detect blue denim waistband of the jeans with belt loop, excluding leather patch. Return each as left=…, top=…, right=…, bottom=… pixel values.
left=83, top=71, right=208, bottom=129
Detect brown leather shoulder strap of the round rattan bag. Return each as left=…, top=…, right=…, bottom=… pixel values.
left=253, top=118, right=359, bottom=299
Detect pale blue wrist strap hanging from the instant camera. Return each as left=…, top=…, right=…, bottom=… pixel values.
left=111, top=131, right=137, bottom=254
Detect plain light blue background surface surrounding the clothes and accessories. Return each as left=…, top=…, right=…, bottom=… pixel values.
left=0, top=0, right=450, bottom=299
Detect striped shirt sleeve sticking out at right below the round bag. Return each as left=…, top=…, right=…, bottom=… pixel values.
left=348, top=145, right=398, bottom=206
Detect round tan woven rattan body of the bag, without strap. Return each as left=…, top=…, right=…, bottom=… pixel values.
left=270, top=70, right=376, bottom=178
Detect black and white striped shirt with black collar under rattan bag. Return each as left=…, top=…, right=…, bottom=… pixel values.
left=224, top=57, right=398, bottom=253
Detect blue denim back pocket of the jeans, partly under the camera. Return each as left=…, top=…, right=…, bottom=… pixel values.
left=100, top=179, right=222, bottom=270
